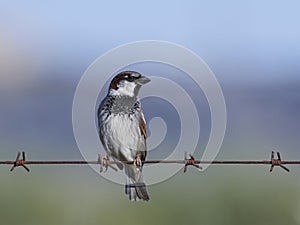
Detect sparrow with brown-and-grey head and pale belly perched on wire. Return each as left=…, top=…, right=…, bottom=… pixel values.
left=97, top=71, right=150, bottom=201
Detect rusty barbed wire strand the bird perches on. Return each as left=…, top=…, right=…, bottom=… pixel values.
left=0, top=151, right=300, bottom=172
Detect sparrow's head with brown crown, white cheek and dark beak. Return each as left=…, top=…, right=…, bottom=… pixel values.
left=108, top=71, right=150, bottom=97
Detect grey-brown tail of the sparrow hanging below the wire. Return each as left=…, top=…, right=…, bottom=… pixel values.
left=125, top=165, right=150, bottom=201
